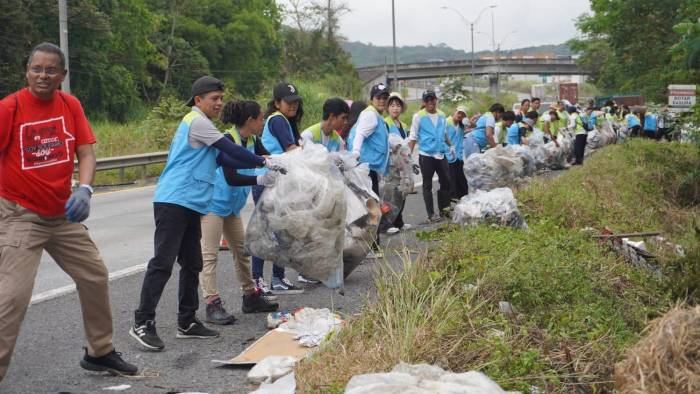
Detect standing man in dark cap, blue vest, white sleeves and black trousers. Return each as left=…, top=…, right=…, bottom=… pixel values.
left=408, top=90, right=457, bottom=222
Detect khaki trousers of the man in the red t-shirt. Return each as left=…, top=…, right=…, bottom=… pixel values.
left=0, top=198, right=114, bottom=380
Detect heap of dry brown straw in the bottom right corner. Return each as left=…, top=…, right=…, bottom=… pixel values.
left=615, top=306, right=700, bottom=394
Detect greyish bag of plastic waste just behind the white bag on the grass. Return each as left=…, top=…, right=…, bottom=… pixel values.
left=464, top=146, right=523, bottom=192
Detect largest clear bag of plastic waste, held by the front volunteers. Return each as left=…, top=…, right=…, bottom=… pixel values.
left=245, top=144, right=347, bottom=288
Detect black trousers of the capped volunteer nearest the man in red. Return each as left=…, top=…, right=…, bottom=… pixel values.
left=134, top=202, right=202, bottom=328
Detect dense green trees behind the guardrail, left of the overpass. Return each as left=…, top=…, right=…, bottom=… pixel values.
left=0, top=0, right=355, bottom=120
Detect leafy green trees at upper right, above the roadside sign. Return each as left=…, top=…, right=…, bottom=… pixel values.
left=570, top=0, right=700, bottom=102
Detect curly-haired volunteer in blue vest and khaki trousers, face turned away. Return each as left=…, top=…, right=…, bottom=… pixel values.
left=199, top=101, right=279, bottom=324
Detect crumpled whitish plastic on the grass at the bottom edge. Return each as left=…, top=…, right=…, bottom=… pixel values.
left=345, top=363, right=506, bottom=394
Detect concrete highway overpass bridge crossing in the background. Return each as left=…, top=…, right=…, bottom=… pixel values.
left=357, top=58, right=588, bottom=92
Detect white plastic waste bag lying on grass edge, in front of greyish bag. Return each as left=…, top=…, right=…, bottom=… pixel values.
left=452, top=187, right=527, bottom=229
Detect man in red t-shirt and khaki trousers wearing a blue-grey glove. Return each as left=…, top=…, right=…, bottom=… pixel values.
left=0, top=43, right=137, bottom=381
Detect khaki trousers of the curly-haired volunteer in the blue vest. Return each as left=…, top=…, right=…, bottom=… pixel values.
left=199, top=213, right=255, bottom=298
